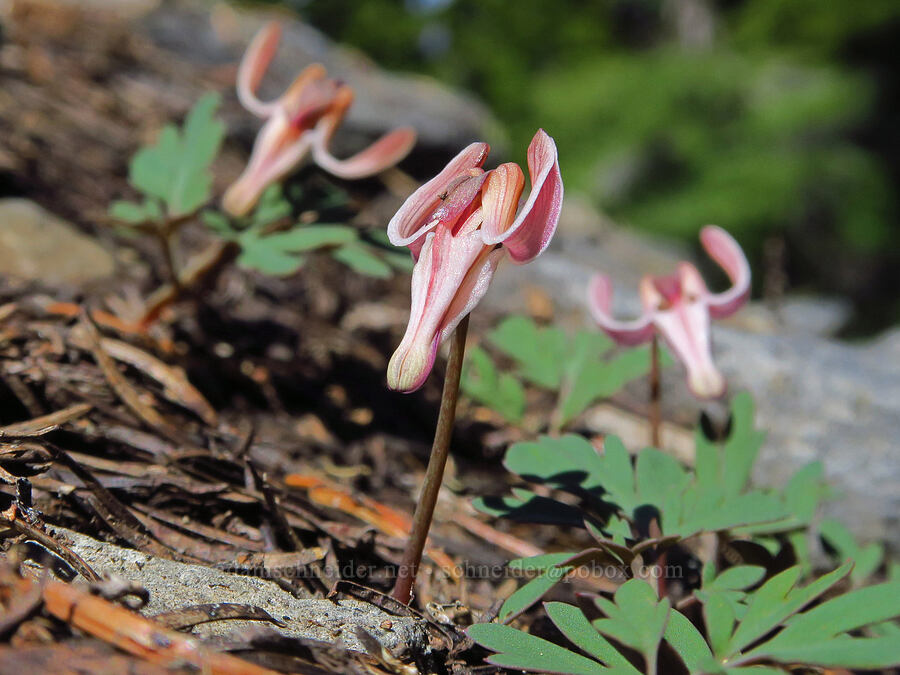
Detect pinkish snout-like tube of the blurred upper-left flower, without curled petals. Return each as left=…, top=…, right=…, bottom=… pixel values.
left=222, top=110, right=312, bottom=216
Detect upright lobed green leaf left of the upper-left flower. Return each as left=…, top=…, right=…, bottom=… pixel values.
left=110, top=93, right=225, bottom=219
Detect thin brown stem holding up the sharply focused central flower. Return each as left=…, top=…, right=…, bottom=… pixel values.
left=391, top=316, right=469, bottom=605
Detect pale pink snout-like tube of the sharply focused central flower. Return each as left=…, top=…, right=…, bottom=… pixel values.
left=387, top=227, right=502, bottom=392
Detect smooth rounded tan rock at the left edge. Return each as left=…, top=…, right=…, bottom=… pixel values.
left=0, top=199, right=115, bottom=286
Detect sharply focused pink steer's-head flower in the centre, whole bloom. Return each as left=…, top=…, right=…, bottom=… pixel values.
left=388, top=129, right=563, bottom=392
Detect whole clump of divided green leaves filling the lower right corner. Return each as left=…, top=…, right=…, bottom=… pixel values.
left=468, top=388, right=900, bottom=675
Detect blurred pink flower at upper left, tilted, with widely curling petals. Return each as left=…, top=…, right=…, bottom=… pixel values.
left=222, top=22, right=416, bottom=216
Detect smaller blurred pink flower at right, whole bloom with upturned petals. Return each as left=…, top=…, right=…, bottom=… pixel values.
left=589, top=225, right=750, bottom=398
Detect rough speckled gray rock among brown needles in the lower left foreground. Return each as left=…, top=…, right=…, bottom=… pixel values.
left=53, top=528, right=425, bottom=652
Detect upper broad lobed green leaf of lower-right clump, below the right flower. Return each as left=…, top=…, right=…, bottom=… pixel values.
left=474, top=394, right=814, bottom=548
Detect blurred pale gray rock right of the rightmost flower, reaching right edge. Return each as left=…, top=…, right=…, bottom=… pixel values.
left=714, top=326, right=900, bottom=552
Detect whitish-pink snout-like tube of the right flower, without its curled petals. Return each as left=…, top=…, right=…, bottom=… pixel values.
left=653, top=300, right=725, bottom=398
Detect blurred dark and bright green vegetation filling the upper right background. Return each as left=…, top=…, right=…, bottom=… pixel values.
left=274, top=0, right=900, bottom=335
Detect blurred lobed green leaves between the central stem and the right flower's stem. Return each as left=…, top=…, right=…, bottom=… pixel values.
left=462, top=316, right=656, bottom=429
